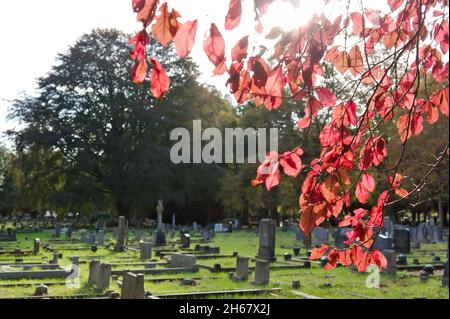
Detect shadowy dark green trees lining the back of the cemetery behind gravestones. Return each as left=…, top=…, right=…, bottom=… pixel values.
left=0, top=30, right=448, bottom=228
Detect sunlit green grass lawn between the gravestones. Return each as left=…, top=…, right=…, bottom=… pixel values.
left=0, top=230, right=449, bottom=299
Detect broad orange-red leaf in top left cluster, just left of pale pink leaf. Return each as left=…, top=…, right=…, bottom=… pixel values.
left=152, top=2, right=180, bottom=46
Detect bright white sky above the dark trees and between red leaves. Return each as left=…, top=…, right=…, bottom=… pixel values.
left=0, top=0, right=330, bottom=148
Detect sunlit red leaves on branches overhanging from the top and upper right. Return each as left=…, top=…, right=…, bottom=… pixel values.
left=130, top=0, right=449, bottom=271
